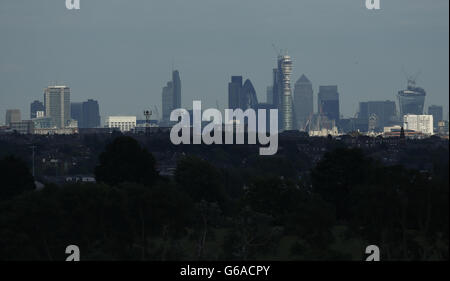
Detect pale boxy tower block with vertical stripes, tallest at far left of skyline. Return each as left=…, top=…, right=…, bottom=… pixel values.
left=44, top=86, right=70, bottom=128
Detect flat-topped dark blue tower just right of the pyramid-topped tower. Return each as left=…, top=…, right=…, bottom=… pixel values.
left=317, top=85, right=339, bottom=122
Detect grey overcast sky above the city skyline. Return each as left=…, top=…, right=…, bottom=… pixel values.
left=0, top=0, right=449, bottom=123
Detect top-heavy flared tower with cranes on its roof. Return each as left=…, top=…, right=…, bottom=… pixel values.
left=397, top=79, right=427, bottom=117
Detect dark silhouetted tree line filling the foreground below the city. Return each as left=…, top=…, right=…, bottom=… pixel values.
left=0, top=136, right=449, bottom=260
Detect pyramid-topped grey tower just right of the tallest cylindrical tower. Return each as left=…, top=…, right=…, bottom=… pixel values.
left=294, top=75, right=314, bottom=131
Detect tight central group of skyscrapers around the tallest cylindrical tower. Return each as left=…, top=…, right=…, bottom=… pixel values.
left=228, top=52, right=339, bottom=131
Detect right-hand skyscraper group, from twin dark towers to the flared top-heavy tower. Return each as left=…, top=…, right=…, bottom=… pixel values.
left=228, top=52, right=448, bottom=135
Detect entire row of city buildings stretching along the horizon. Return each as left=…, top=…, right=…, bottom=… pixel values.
left=6, top=54, right=448, bottom=136
